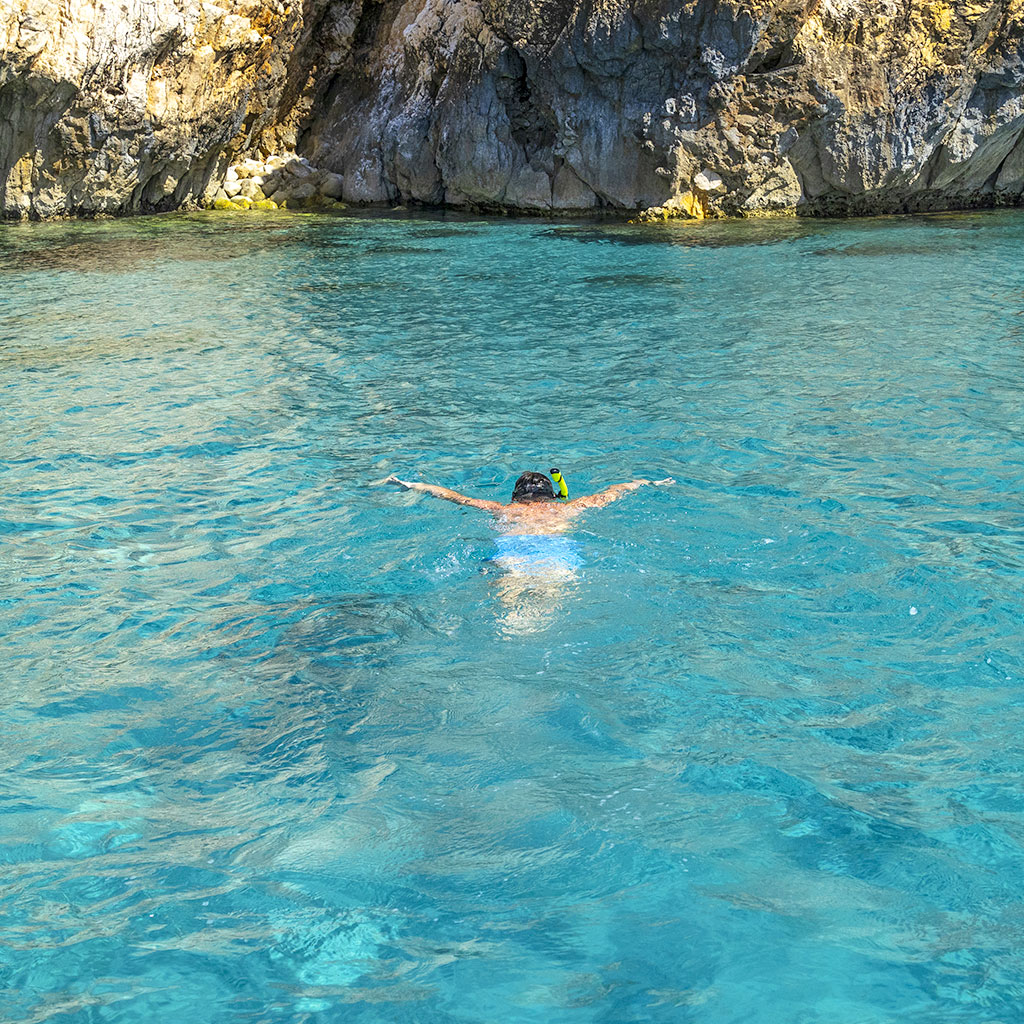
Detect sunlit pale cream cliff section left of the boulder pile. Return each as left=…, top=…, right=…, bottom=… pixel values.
left=0, top=0, right=327, bottom=217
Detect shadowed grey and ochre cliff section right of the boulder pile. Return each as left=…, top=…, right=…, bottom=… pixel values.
left=299, top=0, right=1024, bottom=215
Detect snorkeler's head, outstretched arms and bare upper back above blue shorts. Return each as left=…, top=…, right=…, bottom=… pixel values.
left=381, top=469, right=676, bottom=535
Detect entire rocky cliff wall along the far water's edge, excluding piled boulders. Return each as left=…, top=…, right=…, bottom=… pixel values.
left=6, top=0, right=1024, bottom=217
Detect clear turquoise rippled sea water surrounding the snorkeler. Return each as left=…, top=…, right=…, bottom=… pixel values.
left=0, top=213, right=1024, bottom=1024
